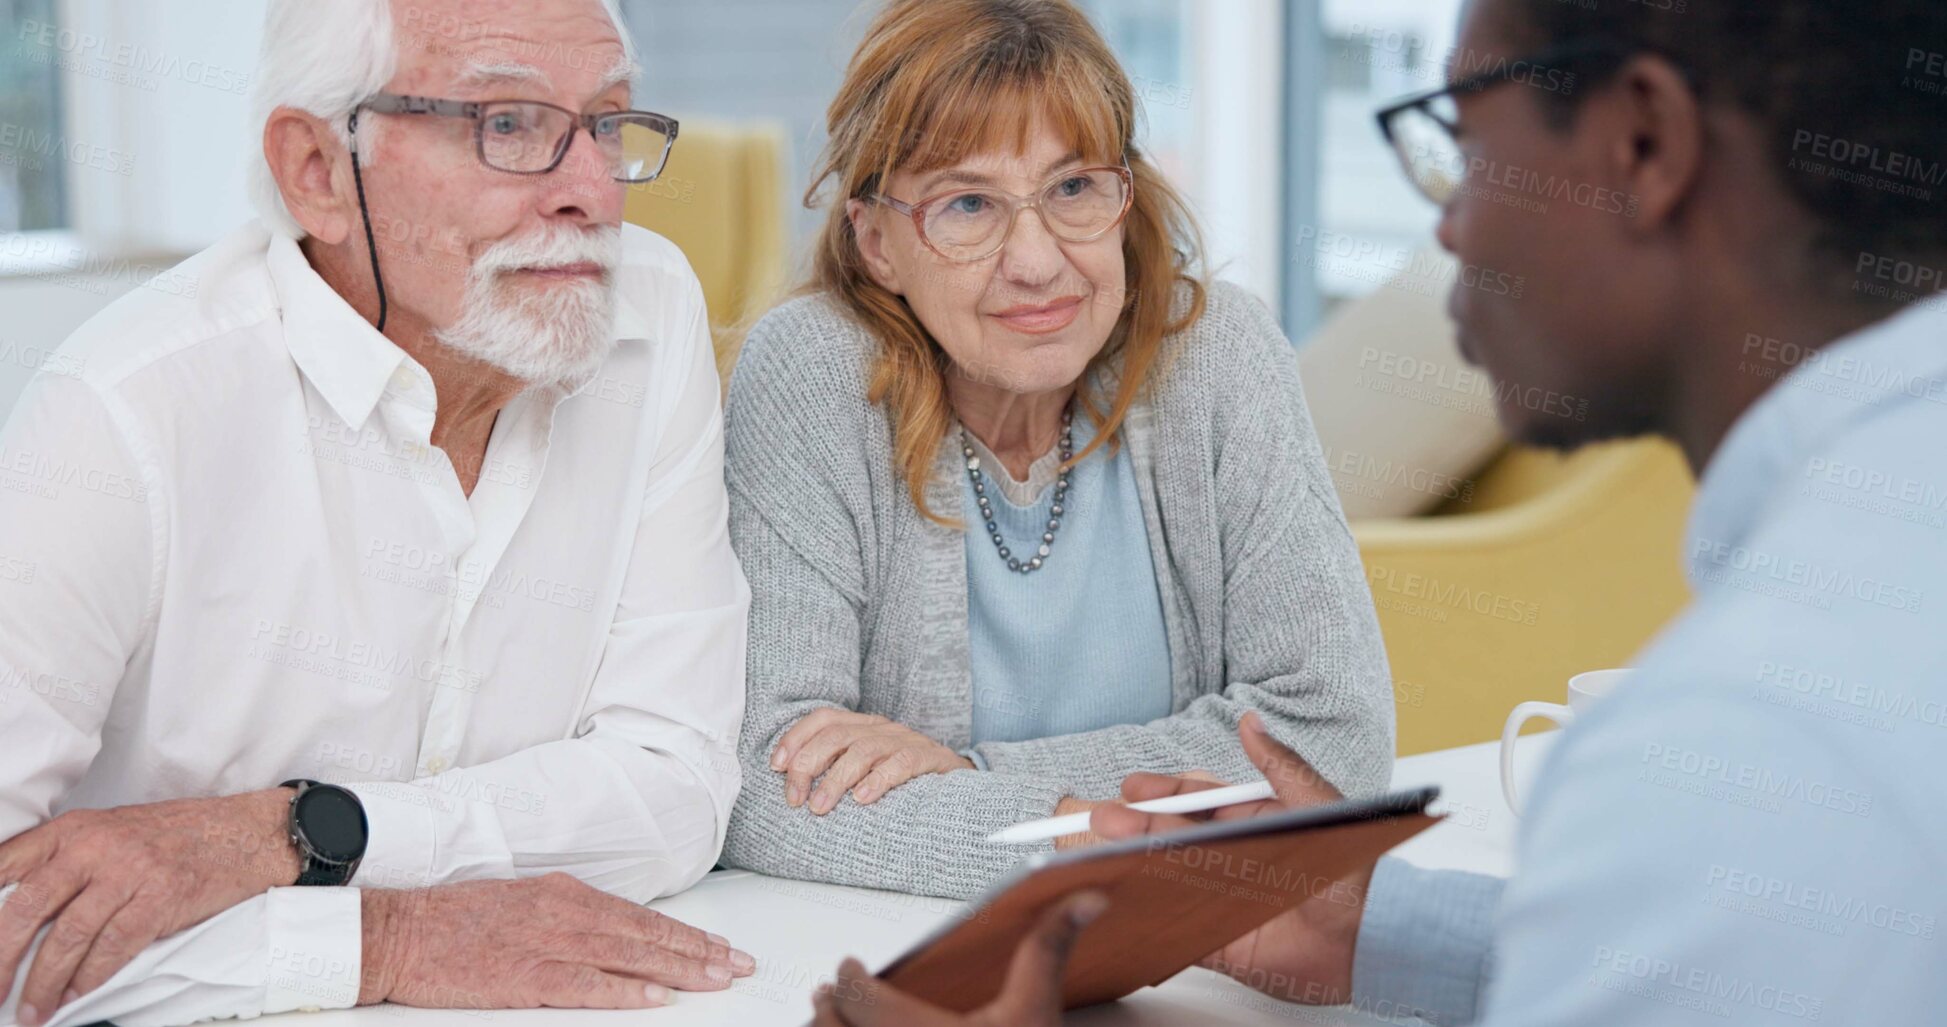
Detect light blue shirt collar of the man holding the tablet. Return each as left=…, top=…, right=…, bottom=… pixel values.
left=1688, top=304, right=1947, bottom=577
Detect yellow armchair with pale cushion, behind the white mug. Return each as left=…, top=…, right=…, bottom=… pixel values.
left=1353, top=440, right=1692, bottom=756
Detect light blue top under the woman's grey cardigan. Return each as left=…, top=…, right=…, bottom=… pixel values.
left=960, top=415, right=1172, bottom=764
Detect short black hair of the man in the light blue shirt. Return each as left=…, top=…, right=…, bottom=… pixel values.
left=1499, top=0, right=1947, bottom=276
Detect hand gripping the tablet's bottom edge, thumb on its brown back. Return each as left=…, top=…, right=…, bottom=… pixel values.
left=812, top=893, right=1108, bottom=1027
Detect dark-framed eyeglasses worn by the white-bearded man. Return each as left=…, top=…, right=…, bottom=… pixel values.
left=354, top=94, right=676, bottom=183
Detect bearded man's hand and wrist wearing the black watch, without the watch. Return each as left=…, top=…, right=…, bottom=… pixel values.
left=0, top=787, right=298, bottom=1025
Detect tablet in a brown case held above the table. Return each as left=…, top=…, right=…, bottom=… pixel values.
left=878, top=787, right=1441, bottom=1013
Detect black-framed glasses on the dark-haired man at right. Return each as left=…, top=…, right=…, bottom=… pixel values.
left=1375, top=39, right=1626, bottom=207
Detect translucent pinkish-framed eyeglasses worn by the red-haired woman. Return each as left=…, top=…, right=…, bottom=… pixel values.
left=870, top=166, right=1135, bottom=263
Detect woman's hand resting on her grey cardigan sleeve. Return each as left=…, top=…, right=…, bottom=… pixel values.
left=771, top=709, right=974, bottom=817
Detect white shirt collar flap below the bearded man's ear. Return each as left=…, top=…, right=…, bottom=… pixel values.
left=267, top=234, right=411, bottom=429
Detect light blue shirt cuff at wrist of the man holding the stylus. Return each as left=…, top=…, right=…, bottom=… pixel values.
left=1351, top=857, right=1507, bottom=1027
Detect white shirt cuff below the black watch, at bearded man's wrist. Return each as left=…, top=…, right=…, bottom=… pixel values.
left=263, top=887, right=364, bottom=1013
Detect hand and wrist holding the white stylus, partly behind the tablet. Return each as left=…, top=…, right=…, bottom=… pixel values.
left=1090, top=713, right=1373, bottom=1006
